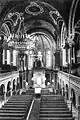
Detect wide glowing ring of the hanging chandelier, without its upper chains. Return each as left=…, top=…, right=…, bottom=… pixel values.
left=8, top=33, right=35, bottom=51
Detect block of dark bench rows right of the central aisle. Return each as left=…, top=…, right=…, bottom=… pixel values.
left=39, top=95, right=74, bottom=120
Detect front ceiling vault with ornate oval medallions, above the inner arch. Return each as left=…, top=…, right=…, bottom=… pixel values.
left=0, top=1, right=67, bottom=34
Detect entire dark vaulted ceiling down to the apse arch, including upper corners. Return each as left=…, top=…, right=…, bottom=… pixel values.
left=0, top=0, right=80, bottom=52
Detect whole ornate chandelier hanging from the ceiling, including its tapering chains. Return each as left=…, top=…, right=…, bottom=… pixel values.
left=3, top=15, right=37, bottom=51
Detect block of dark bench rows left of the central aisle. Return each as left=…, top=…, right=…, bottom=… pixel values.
left=0, top=95, right=32, bottom=120
